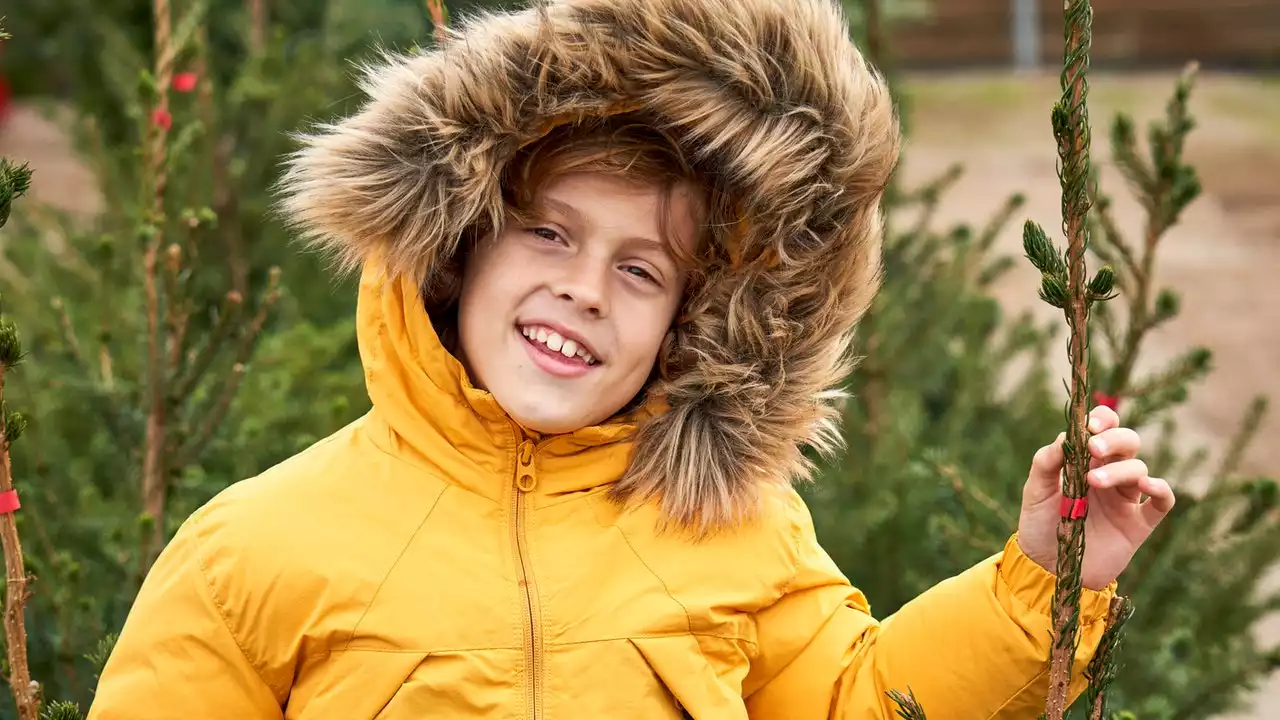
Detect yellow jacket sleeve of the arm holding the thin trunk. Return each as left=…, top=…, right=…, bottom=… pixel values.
left=744, top=491, right=1115, bottom=720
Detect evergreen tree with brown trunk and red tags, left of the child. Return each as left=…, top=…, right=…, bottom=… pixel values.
left=0, top=0, right=376, bottom=716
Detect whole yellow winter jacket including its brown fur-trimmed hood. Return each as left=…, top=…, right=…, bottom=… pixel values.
left=90, top=0, right=1114, bottom=720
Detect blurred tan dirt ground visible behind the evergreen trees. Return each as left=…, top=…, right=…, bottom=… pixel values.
left=0, top=73, right=1280, bottom=720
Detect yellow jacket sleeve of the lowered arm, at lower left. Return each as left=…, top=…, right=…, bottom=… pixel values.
left=88, top=504, right=283, bottom=720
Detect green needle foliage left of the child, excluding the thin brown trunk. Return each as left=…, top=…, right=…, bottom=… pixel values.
left=0, top=0, right=425, bottom=717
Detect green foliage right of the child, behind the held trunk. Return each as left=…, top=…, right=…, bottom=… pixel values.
left=805, top=63, right=1280, bottom=720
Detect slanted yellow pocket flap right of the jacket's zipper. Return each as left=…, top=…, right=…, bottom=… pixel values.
left=631, top=635, right=748, bottom=720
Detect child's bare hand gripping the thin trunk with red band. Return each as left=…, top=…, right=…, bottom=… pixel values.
left=1018, top=406, right=1174, bottom=591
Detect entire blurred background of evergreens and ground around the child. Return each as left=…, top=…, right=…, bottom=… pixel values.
left=0, top=0, right=1280, bottom=720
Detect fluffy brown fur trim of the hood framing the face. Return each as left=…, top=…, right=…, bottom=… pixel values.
left=282, top=0, right=900, bottom=529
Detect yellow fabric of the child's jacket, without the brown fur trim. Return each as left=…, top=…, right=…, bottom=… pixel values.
left=90, top=265, right=1111, bottom=720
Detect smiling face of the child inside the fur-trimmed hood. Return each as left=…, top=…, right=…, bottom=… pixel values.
left=458, top=174, right=695, bottom=433
